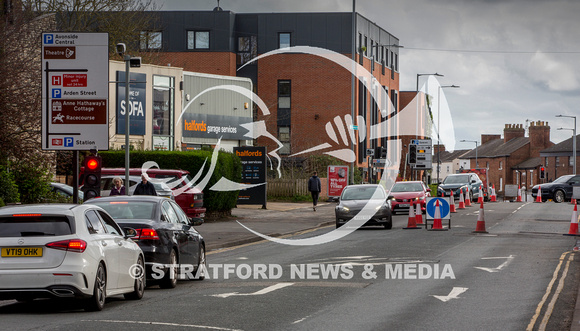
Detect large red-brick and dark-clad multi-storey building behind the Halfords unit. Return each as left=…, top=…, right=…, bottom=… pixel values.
left=141, top=8, right=399, bottom=174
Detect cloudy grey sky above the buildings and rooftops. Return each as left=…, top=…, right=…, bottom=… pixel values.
left=158, top=0, right=580, bottom=149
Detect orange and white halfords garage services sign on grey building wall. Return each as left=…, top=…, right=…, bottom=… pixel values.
left=182, top=113, right=253, bottom=140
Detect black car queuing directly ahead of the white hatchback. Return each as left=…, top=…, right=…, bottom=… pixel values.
left=86, top=195, right=206, bottom=288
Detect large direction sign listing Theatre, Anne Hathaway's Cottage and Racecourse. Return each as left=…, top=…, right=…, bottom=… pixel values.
left=42, top=32, right=109, bottom=150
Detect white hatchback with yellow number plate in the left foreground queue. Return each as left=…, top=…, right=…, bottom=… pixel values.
left=0, top=204, right=145, bottom=310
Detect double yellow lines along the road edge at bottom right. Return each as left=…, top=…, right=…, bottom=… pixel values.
left=526, top=251, right=575, bottom=331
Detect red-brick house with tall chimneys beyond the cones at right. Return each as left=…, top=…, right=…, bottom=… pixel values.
left=462, top=121, right=553, bottom=192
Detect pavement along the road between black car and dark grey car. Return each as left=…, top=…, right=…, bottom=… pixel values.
left=196, top=202, right=336, bottom=252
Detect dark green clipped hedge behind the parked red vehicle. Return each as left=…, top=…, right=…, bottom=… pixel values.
left=99, top=150, right=242, bottom=212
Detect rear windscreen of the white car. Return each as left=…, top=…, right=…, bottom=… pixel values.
left=0, top=214, right=73, bottom=237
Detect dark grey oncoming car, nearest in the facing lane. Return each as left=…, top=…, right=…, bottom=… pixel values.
left=335, top=184, right=393, bottom=229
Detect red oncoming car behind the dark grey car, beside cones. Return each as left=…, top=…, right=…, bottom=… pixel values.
left=389, top=181, right=431, bottom=214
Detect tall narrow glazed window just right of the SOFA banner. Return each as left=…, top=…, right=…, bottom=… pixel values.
left=153, top=75, right=175, bottom=150
